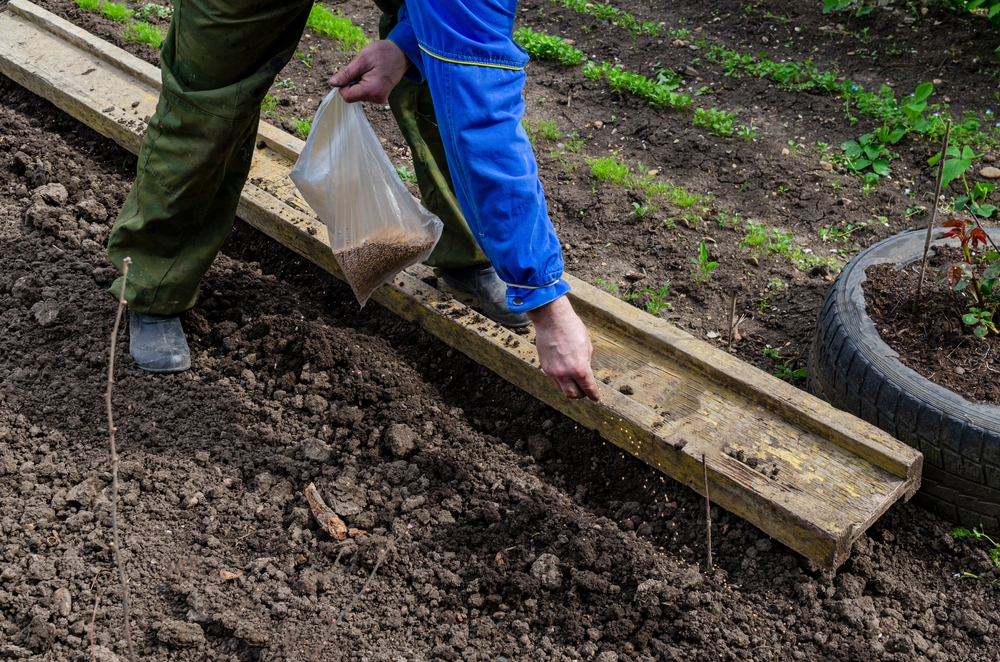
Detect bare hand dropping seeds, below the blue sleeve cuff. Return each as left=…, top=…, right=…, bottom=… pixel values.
left=528, top=296, right=601, bottom=402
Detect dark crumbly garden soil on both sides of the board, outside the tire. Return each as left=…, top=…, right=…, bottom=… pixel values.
left=0, top=0, right=1000, bottom=662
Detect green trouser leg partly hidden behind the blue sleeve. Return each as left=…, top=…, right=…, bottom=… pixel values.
left=375, top=0, right=490, bottom=268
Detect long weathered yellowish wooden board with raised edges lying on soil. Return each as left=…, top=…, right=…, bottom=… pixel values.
left=0, top=0, right=921, bottom=567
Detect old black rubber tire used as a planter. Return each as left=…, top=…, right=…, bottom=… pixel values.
left=807, top=230, right=1000, bottom=533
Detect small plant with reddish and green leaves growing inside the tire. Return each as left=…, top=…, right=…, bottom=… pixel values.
left=944, top=218, right=1000, bottom=338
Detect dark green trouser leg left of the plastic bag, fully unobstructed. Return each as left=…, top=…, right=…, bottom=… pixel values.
left=108, top=0, right=312, bottom=315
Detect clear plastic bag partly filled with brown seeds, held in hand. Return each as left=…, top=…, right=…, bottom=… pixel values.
left=289, top=89, right=444, bottom=307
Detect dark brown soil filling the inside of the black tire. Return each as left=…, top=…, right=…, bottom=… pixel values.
left=861, top=248, right=1000, bottom=405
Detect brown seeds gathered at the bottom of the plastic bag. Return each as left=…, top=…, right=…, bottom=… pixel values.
left=333, top=229, right=434, bottom=305
